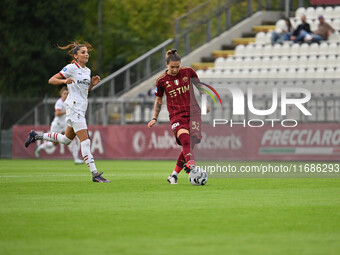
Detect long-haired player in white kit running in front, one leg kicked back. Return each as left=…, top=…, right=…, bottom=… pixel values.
left=25, top=42, right=110, bottom=182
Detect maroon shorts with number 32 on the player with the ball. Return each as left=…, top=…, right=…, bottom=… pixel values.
left=170, top=116, right=202, bottom=145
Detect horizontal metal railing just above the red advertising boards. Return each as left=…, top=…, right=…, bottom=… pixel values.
left=16, top=80, right=340, bottom=126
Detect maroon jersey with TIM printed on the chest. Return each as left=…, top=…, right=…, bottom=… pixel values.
left=155, top=67, right=201, bottom=120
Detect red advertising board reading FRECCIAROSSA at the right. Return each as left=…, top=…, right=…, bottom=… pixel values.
left=247, top=124, right=340, bottom=161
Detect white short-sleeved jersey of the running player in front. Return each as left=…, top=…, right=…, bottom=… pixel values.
left=59, top=62, right=91, bottom=117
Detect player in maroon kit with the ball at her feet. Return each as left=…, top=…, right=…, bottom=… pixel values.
left=148, top=49, right=202, bottom=184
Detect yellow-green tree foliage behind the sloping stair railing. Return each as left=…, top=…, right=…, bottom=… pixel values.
left=75, top=0, right=206, bottom=77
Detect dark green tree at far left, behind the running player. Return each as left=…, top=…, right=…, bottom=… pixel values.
left=0, top=0, right=85, bottom=97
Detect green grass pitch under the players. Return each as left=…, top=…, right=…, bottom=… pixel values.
left=0, top=160, right=340, bottom=255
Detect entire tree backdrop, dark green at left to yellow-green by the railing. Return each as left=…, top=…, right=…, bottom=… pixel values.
left=0, top=0, right=215, bottom=98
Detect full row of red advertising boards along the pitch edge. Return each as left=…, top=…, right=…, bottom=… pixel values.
left=12, top=124, right=340, bottom=161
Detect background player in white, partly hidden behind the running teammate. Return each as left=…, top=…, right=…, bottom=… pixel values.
left=35, top=87, right=84, bottom=164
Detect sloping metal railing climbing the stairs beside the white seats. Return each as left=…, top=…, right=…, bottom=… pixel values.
left=94, top=0, right=308, bottom=97
